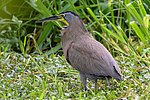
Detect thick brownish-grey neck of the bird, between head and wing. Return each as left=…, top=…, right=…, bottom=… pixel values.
left=61, top=19, right=90, bottom=53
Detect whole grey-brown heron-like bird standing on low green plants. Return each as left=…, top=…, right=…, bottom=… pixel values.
left=38, top=11, right=123, bottom=91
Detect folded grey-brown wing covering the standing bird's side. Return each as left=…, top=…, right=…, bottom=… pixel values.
left=68, top=36, right=120, bottom=77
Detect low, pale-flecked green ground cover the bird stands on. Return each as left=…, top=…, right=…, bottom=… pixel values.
left=0, top=52, right=150, bottom=100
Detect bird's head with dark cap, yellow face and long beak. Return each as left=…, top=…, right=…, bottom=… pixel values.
left=38, top=11, right=80, bottom=26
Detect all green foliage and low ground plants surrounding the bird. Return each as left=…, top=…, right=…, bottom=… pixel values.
left=0, top=0, right=150, bottom=100
